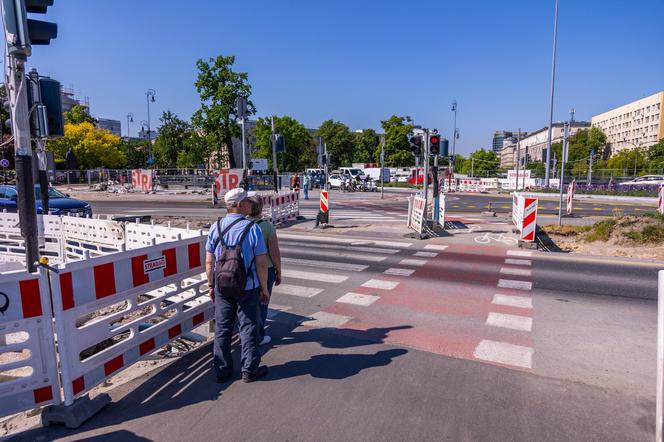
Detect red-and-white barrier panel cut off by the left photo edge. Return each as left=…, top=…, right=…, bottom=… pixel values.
left=0, top=271, right=60, bottom=416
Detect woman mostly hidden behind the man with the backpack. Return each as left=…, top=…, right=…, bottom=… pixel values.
left=249, top=195, right=281, bottom=345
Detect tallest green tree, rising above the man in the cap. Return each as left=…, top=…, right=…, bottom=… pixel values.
left=191, top=55, right=256, bottom=167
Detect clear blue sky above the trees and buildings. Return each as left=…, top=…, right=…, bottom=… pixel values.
left=9, top=0, right=664, bottom=153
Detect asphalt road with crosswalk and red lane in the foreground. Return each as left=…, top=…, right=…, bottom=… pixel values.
left=16, top=231, right=657, bottom=441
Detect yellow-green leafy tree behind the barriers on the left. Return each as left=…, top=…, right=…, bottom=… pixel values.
left=46, top=122, right=126, bottom=169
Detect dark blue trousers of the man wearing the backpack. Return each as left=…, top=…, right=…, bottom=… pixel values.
left=212, top=289, right=261, bottom=377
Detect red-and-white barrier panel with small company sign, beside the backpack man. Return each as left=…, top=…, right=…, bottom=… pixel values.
left=51, top=236, right=213, bottom=405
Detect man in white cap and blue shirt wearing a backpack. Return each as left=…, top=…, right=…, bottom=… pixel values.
left=205, top=188, right=270, bottom=382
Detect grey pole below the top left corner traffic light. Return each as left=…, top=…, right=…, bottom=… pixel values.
left=7, top=55, right=39, bottom=273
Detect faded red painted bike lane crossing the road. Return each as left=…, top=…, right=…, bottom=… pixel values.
left=324, top=245, right=533, bottom=368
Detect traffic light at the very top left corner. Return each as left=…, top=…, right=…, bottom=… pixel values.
left=2, top=0, right=58, bottom=58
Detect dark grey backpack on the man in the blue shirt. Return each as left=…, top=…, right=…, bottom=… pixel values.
left=214, top=218, right=256, bottom=298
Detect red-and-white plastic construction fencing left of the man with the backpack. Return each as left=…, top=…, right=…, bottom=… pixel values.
left=0, top=214, right=213, bottom=424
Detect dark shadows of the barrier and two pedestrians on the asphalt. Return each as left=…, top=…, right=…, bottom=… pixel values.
left=9, top=312, right=411, bottom=441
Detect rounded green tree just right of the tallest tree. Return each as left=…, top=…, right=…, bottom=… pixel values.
left=252, top=116, right=316, bottom=172
